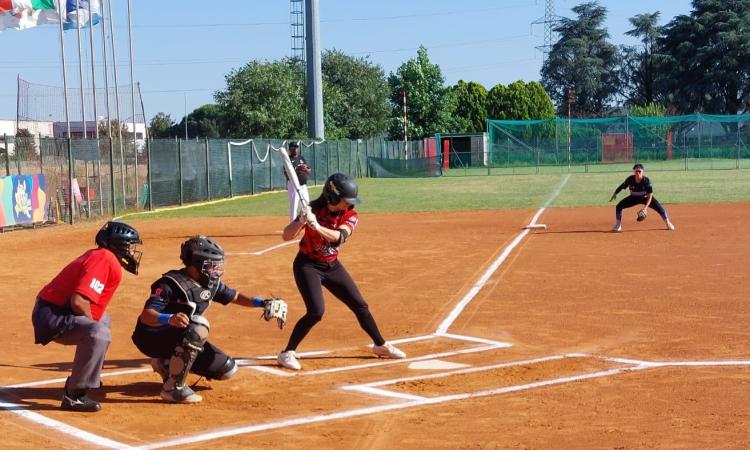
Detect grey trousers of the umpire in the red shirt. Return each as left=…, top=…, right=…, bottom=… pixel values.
left=33, top=300, right=112, bottom=390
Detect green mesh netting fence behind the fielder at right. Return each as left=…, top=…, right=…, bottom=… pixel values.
left=488, top=114, right=750, bottom=171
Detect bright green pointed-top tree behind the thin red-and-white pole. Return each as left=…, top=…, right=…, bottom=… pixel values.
left=388, top=46, right=452, bottom=139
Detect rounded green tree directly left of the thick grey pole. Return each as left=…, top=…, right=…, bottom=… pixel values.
left=214, top=59, right=307, bottom=138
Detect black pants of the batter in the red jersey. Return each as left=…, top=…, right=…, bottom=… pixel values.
left=284, top=253, right=385, bottom=351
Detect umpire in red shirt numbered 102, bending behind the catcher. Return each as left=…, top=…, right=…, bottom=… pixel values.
left=31, top=222, right=142, bottom=412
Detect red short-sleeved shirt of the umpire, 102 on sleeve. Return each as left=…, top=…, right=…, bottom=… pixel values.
left=38, top=248, right=122, bottom=320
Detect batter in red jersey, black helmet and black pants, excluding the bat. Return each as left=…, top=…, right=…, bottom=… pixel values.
left=277, top=173, right=406, bottom=370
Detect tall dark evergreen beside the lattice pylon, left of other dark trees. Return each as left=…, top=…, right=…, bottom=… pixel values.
left=542, top=2, right=620, bottom=116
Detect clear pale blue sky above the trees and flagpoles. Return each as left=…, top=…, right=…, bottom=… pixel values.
left=0, top=0, right=691, bottom=122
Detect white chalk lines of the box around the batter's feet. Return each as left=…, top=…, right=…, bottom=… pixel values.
left=238, top=333, right=513, bottom=377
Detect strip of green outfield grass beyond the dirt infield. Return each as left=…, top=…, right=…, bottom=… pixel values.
left=123, top=167, right=750, bottom=218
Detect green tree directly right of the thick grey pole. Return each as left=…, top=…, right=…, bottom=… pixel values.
left=321, top=50, right=390, bottom=139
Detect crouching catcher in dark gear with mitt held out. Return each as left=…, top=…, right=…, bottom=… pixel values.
left=133, top=236, right=287, bottom=403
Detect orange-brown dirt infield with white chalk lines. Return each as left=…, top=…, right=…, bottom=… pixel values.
left=0, top=204, right=750, bottom=449
